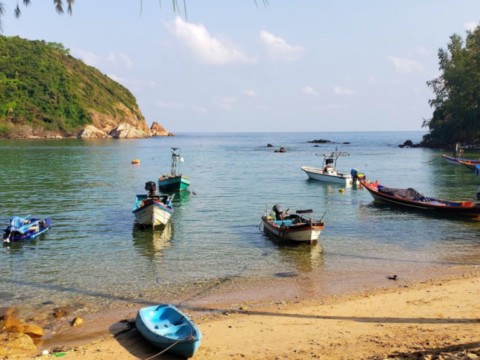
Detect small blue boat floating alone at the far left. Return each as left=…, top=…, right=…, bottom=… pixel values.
left=3, top=216, right=52, bottom=244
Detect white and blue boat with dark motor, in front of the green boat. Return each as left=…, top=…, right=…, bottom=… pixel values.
left=133, top=181, right=173, bottom=227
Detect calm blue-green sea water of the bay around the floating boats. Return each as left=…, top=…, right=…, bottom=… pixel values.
left=0, top=132, right=480, bottom=316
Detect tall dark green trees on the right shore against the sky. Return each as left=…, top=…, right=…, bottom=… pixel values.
left=423, top=26, right=480, bottom=146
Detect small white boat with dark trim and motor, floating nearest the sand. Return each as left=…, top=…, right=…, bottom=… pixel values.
left=261, top=204, right=325, bottom=244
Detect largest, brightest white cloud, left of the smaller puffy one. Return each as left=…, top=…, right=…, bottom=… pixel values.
left=167, top=17, right=254, bottom=65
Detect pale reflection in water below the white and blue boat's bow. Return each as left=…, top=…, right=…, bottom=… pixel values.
left=132, top=221, right=173, bottom=257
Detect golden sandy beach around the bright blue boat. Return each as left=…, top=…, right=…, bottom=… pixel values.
left=4, top=267, right=480, bottom=360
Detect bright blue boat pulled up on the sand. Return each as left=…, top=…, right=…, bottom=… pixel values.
left=135, top=304, right=202, bottom=358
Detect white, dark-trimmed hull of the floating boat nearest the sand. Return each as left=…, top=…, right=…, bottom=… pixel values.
left=262, top=215, right=324, bottom=244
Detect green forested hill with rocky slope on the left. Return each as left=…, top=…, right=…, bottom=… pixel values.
left=0, top=36, right=149, bottom=137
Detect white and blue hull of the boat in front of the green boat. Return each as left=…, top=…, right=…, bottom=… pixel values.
left=133, top=195, right=173, bottom=227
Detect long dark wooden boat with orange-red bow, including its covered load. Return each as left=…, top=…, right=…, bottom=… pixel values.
left=362, top=181, right=480, bottom=220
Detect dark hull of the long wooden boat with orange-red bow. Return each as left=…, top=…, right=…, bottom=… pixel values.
left=362, top=182, right=480, bottom=220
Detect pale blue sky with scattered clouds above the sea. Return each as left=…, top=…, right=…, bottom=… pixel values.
left=2, top=0, right=480, bottom=133
